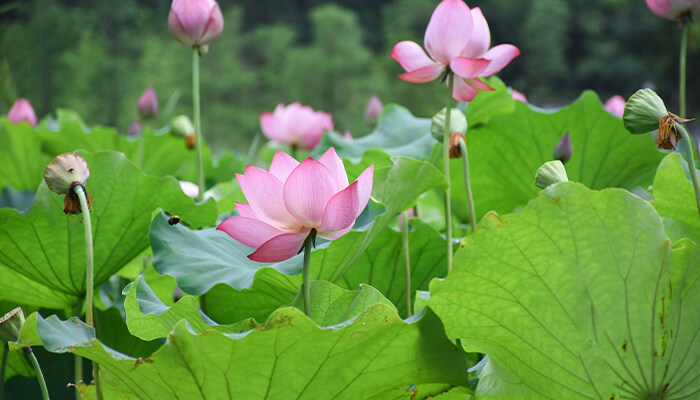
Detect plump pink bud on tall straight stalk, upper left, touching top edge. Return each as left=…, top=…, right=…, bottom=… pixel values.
left=168, top=0, right=224, bottom=46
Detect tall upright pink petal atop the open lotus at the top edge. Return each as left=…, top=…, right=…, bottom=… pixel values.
left=425, top=0, right=472, bottom=64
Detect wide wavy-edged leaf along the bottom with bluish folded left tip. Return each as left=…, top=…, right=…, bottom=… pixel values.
left=17, top=304, right=466, bottom=399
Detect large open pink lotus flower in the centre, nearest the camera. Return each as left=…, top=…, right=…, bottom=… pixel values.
left=216, top=147, right=374, bottom=262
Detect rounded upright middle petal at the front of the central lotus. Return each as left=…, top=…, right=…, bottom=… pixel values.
left=284, top=157, right=337, bottom=228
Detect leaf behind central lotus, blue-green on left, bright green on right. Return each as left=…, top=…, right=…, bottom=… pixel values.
left=150, top=157, right=445, bottom=294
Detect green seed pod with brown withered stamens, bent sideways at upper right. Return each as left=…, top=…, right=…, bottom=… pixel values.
left=622, top=89, right=692, bottom=150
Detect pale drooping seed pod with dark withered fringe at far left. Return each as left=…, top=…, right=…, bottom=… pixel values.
left=44, top=153, right=90, bottom=214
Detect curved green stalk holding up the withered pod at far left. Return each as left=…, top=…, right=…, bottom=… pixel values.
left=74, top=185, right=102, bottom=399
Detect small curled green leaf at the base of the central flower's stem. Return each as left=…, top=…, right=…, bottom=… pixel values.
left=292, top=281, right=396, bottom=326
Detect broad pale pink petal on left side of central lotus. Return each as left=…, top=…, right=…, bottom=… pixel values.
left=236, top=165, right=299, bottom=229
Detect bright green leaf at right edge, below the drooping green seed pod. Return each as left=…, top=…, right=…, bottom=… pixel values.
left=651, top=153, right=700, bottom=243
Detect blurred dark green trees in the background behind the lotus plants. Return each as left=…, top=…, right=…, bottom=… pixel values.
left=0, top=0, right=700, bottom=151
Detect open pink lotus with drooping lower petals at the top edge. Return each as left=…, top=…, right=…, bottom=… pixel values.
left=391, top=0, right=520, bottom=101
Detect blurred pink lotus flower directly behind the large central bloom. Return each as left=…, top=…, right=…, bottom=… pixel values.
left=260, top=102, right=333, bottom=150
